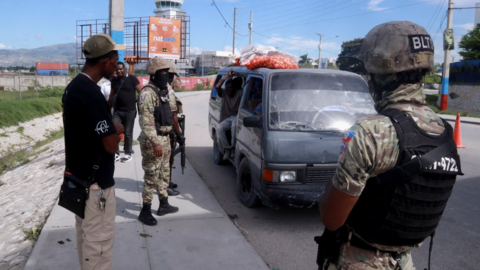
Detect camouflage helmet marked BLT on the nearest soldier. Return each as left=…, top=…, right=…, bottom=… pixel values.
left=358, top=21, right=434, bottom=74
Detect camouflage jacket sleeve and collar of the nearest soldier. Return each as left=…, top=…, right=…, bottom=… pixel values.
left=332, top=84, right=445, bottom=251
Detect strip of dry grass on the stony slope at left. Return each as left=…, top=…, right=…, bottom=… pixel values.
left=0, top=129, right=64, bottom=174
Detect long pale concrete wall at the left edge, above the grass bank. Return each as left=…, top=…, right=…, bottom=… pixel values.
left=0, top=74, right=70, bottom=91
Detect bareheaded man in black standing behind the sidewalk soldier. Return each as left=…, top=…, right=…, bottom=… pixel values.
left=110, top=62, right=142, bottom=162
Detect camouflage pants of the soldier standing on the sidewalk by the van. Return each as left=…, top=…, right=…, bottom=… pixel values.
left=139, top=136, right=171, bottom=203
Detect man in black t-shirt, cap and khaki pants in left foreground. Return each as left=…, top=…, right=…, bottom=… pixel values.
left=62, top=34, right=125, bottom=270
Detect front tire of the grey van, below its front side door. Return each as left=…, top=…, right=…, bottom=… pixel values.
left=237, top=158, right=261, bottom=208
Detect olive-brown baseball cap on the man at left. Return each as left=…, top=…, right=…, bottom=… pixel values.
left=82, top=34, right=126, bottom=59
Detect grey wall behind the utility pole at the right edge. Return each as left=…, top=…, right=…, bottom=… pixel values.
left=437, top=85, right=480, bottom=113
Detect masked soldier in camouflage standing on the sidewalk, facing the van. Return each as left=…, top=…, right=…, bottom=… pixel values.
left=137, top=57, right=178, bottom=226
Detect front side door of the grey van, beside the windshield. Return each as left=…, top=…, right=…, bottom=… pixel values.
left=237, top=75, right=265, bottom=169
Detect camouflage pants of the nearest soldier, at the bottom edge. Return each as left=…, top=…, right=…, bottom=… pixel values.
left=328, top=245, right=415, bottom=270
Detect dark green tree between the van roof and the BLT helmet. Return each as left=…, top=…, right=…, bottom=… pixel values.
left=337, top=38, right=367, bottom=74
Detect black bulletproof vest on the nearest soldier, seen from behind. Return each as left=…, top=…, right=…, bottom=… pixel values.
left=346, top=109, right=463, bottom=246
